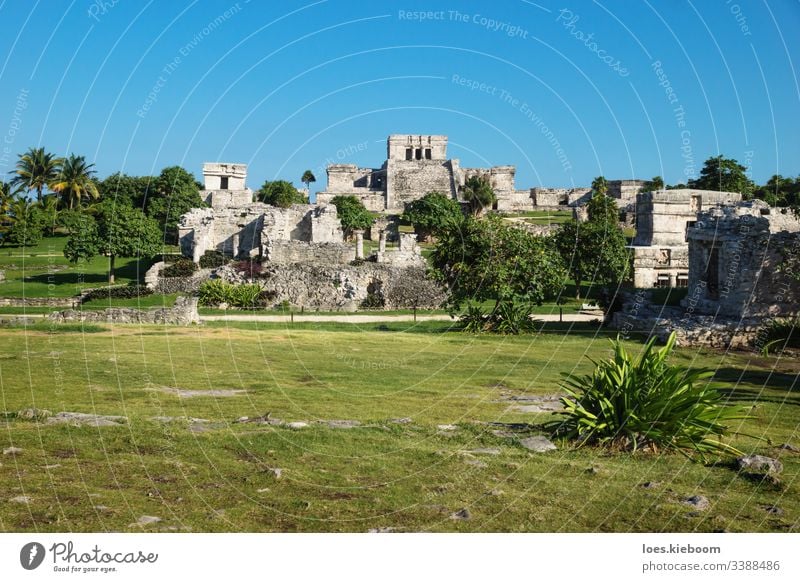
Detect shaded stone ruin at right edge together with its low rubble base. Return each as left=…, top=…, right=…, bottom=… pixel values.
left=612, top=200, right=800, bottom=349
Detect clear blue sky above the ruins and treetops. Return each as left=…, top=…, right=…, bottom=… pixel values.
left=0, top=0, right=800, bottom=195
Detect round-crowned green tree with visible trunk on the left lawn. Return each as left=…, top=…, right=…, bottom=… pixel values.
left=64, top=200, right=162, bottom=284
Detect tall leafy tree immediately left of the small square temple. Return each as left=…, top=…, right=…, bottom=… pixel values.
left=146, top=166, right=205, bottom=243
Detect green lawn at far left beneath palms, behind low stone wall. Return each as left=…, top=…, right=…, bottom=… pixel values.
left=0, top=236, right=173, bottom=297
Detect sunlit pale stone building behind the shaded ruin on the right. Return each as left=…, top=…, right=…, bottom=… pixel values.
left=630, top=188, right=742, bottom=288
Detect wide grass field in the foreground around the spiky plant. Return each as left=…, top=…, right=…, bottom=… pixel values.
left=0, top=322, right=800, bottom=532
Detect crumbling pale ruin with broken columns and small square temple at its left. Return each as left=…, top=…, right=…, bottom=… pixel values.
left=176, top=164, right=445, bottom=311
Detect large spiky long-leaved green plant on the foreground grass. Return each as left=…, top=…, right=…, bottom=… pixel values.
left=547, top=332, right=747, bottom=459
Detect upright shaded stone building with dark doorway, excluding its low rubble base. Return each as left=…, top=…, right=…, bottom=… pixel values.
left=684, top=200, right=800, bottom=318
